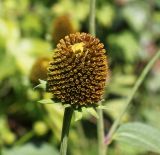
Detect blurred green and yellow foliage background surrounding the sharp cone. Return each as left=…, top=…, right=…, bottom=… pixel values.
left=0, top=0, right=160, bottom=155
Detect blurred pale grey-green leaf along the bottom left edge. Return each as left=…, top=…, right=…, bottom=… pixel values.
left=2, top=144, right=59, bottom=155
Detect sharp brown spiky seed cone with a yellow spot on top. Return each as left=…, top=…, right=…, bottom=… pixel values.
left=47, top=32, right=108, bottom=107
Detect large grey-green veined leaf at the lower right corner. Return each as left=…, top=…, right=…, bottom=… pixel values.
left=114, top=123, right=160, bottom=153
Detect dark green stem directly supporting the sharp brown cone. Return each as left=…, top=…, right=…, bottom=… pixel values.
left=60, top=107, right=73, bottom=155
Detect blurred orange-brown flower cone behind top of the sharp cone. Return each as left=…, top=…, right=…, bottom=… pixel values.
left=52, top=15, right=75, bottom=44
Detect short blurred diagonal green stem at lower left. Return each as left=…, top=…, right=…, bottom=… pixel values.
left=14, top=130, right=35, bottom=146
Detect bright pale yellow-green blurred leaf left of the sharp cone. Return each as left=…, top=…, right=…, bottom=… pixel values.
left=9, top=38, right=51, bottom=75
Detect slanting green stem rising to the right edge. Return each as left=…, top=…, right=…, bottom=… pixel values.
left=106, top=50, right=160, bottom=145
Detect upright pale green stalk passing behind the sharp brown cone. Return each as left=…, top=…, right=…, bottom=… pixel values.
left=89, top=0, right=106, bottom=155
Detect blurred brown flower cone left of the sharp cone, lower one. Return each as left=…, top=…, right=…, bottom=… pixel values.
left=29, top=57, right=51, bottom=86
